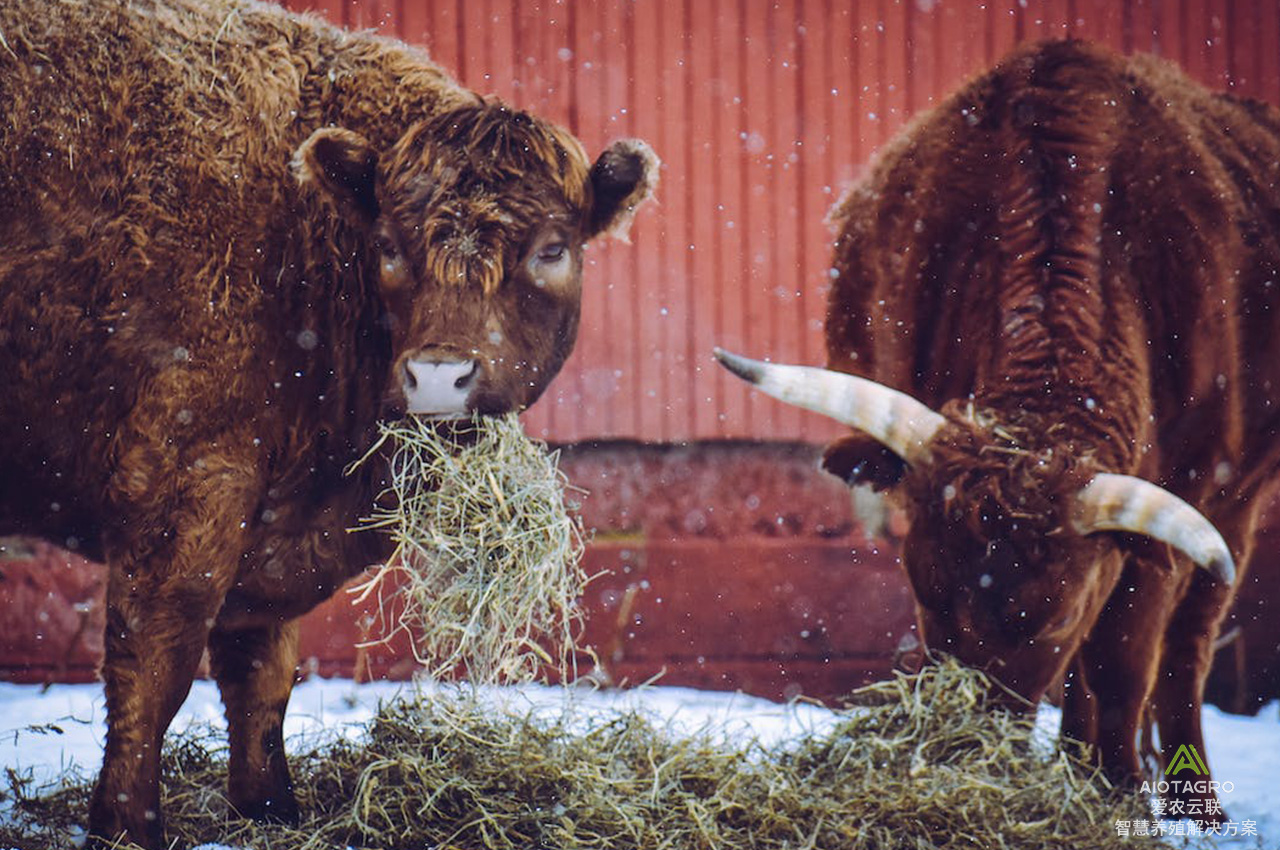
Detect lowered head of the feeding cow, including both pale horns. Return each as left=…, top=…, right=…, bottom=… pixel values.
left=716, top=351, right=1234, bottom=702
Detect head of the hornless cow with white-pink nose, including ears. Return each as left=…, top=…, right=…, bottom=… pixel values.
left=294, top=102, right=658, bottom=419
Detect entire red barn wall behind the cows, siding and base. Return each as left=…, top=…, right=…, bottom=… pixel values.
left=0, top=0, right=1280, bottom=707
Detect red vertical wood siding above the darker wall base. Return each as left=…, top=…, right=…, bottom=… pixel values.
left=277, top=0, right=1280, bottom=442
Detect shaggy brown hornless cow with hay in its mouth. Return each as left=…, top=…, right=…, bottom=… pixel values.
left=0, top=0, right=657, bottom=847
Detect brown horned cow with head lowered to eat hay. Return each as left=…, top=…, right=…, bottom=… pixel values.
left=722, top=41, right=1280, bottom=821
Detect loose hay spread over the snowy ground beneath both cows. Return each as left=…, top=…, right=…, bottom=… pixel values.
left=0, top=663, right=1203, bottom=850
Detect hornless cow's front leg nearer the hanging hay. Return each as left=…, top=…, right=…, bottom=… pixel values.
left=209, top=620, right=298, bottom=823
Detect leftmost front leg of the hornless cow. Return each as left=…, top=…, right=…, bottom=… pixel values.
left=88, top=563, right=221, bottom=849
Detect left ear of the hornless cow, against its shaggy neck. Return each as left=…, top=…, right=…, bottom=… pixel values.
left=293, top=127, right=378, bottom=225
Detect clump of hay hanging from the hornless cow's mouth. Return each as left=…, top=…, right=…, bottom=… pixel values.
left=352, top=413, right=589, bottom=684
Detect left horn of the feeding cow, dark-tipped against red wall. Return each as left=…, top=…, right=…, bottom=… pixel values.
left=714, top=348, right=946, bottom=465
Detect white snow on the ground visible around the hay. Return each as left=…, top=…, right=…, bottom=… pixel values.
left=0, top=678, right=1280, bottom=850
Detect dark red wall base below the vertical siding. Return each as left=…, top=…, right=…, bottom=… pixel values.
left=0, top=443, right=1280, bottom=710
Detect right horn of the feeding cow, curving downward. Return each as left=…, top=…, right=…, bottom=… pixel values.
left=1071, top=472, right=1235, bottom=585
